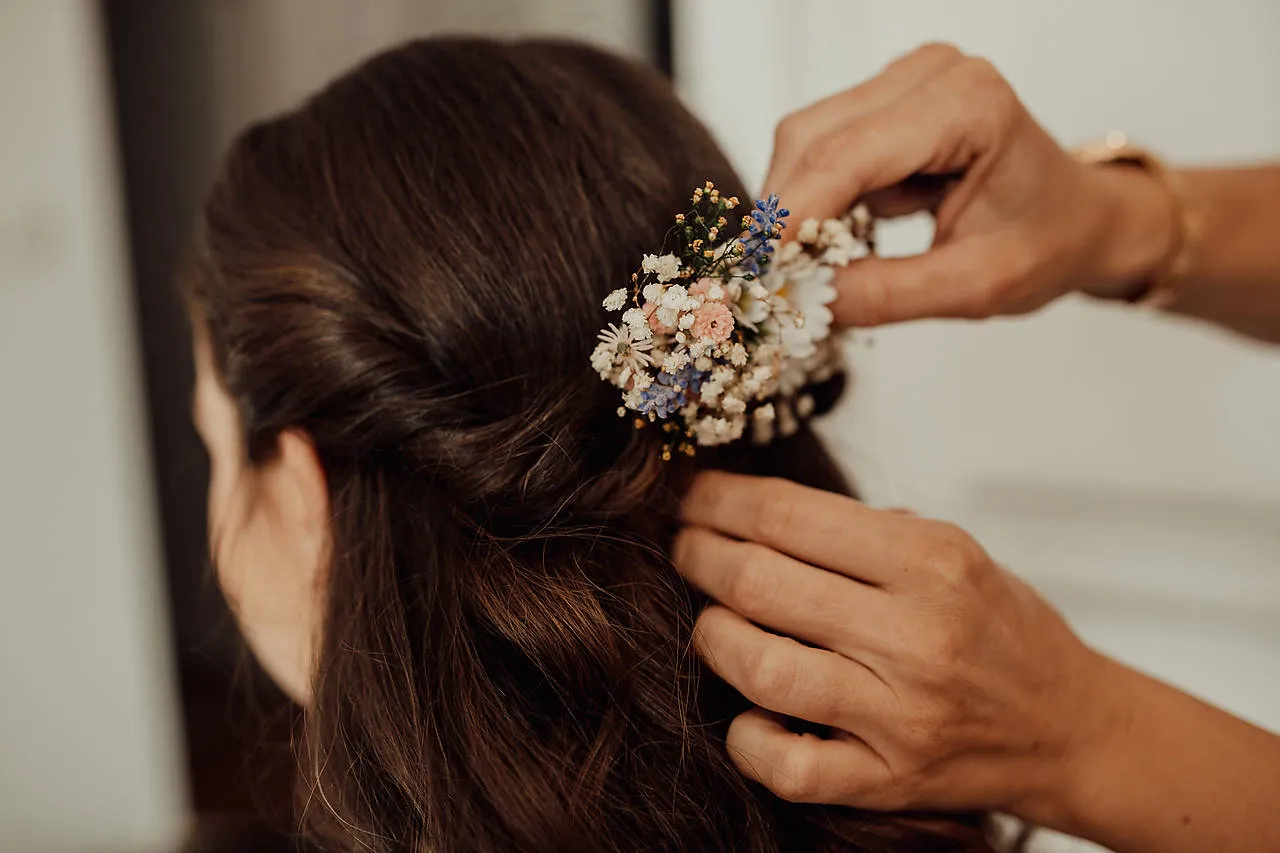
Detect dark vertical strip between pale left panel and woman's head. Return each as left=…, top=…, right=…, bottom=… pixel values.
left=99, top=0, right=292, bottom=852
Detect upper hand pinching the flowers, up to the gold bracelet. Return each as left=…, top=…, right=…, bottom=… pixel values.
left=764, top=45, right=1174, bottom=325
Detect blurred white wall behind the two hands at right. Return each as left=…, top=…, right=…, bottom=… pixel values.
left=675, top=0, right=1280, bottom=845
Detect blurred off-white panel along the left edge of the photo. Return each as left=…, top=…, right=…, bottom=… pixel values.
left=0, top=0, right=186, bottom=853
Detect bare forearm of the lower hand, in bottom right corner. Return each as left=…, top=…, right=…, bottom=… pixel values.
left=1028, top=648, right=1280, bottom=853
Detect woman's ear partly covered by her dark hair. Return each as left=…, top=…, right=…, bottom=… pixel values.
left=256, top=429, right=329, bottom=592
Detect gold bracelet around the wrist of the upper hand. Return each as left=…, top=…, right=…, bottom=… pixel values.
left=1071, top=131, right=1201, bottom=309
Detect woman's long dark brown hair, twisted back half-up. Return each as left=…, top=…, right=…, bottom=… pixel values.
left=187, top=40, right=988, bottom=853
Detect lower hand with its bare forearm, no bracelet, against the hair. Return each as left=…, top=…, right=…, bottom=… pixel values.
left=675, top=473, right=1280, bottom=853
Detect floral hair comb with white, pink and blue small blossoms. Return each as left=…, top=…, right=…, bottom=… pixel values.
left=591, top=181, right=874, bottom=460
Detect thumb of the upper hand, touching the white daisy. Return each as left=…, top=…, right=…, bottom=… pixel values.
left=831, top=237, right=1002, bottom=327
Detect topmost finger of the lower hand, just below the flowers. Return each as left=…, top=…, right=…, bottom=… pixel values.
left=684, top=471, right=931, bottom=587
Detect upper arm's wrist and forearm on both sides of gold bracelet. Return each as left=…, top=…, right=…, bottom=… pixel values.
left=1087, top=167, right=1280, bottom=343
